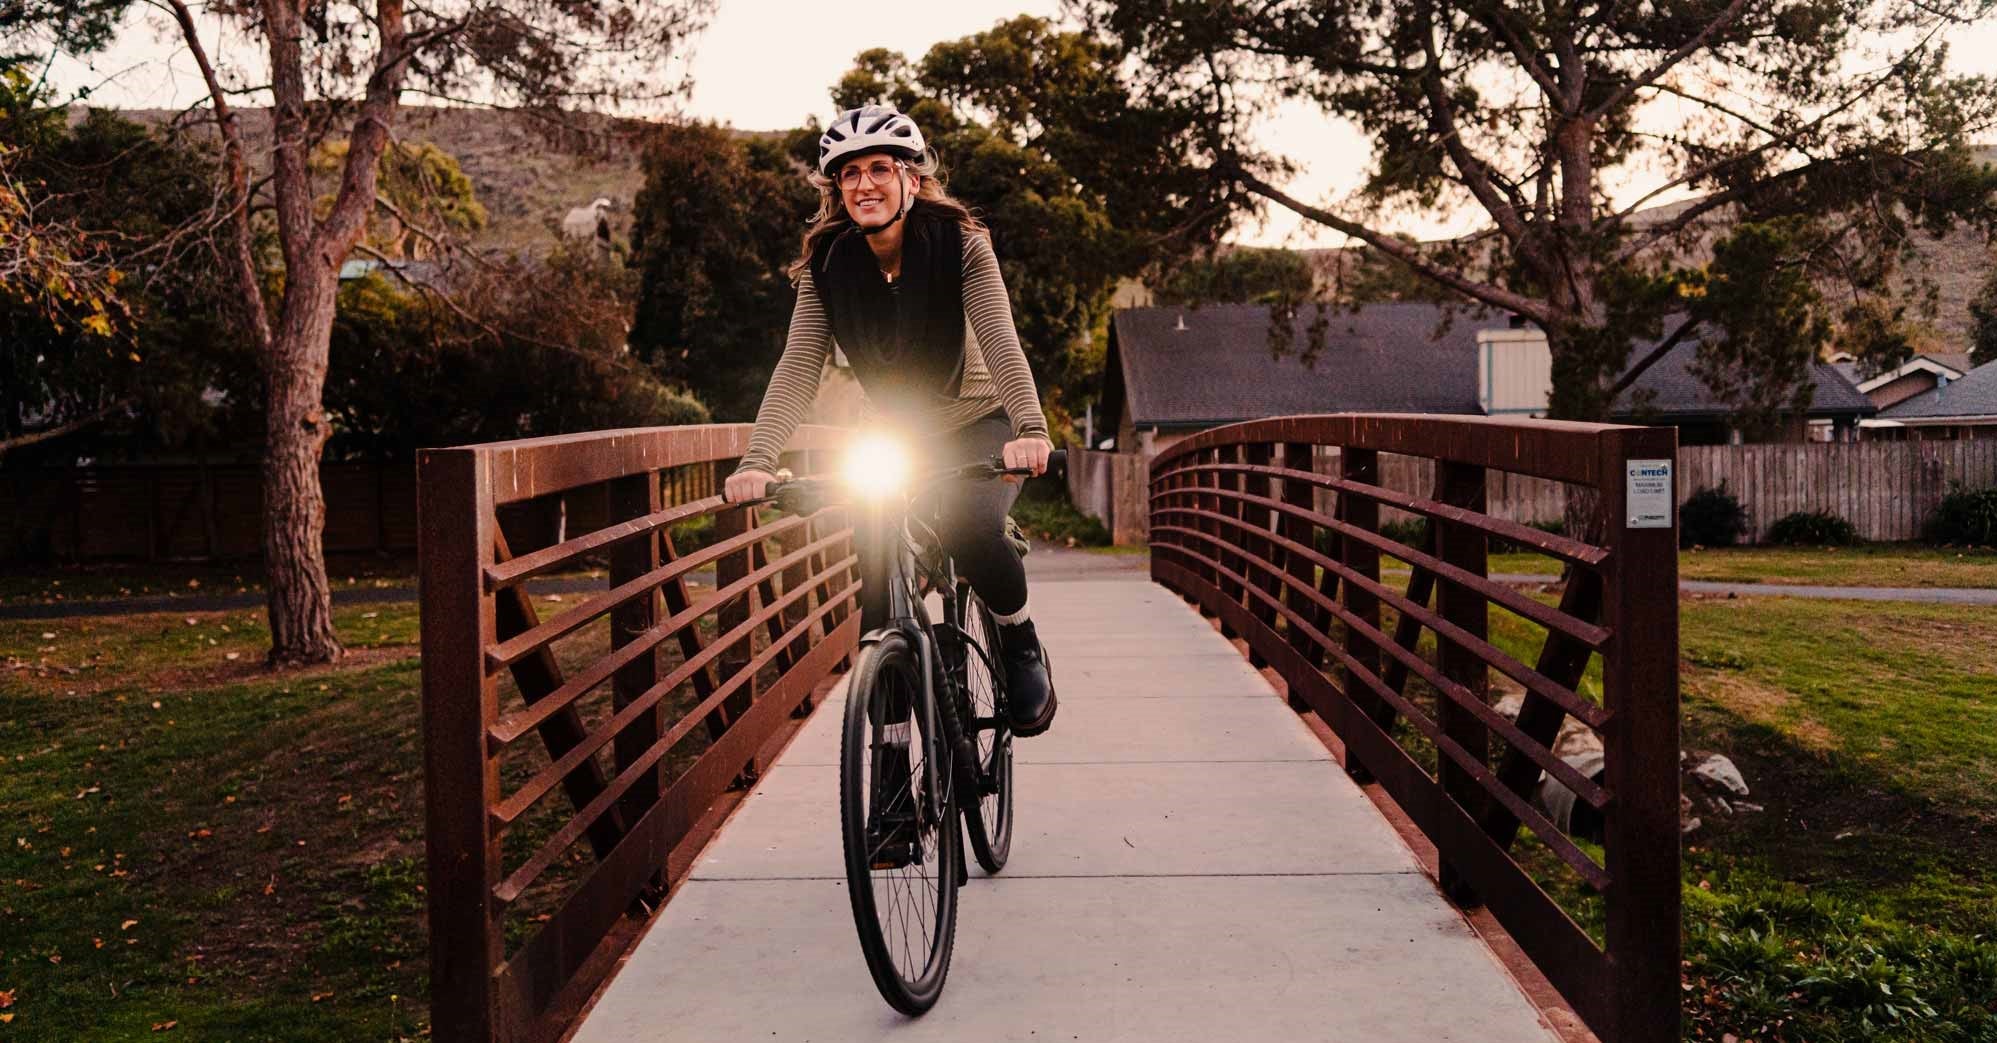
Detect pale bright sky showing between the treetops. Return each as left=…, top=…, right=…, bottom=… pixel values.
left=35, top=0, right=1997, bottom=248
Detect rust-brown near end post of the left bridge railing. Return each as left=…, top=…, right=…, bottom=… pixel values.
left=417, top=450, right=505, bottom=1043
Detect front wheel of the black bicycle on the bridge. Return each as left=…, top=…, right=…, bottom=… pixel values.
left=839, top=633, right=965, bottom=1015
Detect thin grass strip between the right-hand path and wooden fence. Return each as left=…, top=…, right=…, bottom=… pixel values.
left=1490, top=543, right=1997, bottom=587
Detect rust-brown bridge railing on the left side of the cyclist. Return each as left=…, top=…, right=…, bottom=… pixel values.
left=417, top=424, right=859, bottom=1043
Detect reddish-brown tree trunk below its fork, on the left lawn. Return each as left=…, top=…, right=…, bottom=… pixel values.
left=264, top=258, right=345, bottom=665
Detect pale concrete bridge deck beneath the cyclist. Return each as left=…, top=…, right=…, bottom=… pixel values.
left=575, top=557, right=1552, bottom=1043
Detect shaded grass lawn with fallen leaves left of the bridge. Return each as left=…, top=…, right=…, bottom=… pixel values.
left=0, top=605, right=427, bottom=1041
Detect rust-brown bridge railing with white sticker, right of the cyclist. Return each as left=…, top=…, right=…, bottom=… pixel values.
left=1150, top=416, right=1679, bottom=1043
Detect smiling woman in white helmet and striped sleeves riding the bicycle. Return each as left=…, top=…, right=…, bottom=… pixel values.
left=725, top=106, right=1056, bottom=735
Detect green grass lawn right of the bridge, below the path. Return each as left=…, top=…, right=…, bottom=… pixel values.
left=1318, top=593, right=1997, bottom=1043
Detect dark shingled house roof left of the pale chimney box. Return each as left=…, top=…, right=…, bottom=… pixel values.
left=1104, top=304, right=1490, bottom=428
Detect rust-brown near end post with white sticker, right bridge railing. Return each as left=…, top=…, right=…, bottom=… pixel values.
left=1600, top=428, right=1679, bottom=1043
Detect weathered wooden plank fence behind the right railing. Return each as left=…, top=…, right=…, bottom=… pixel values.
left=1068, top=440, right=1997, bottom=543
